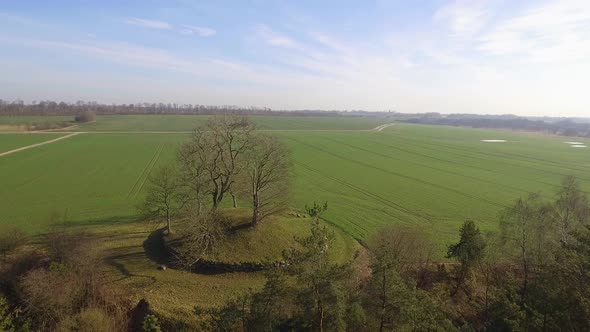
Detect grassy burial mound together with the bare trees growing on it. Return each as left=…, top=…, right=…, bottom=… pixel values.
left=141, top=116, right=354, bottom=273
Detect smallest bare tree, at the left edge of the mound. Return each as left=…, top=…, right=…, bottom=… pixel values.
left=140, top=166, right=187, bottom=234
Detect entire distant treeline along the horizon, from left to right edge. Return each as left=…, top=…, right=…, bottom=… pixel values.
left=0, top=99, right=590, bottom=137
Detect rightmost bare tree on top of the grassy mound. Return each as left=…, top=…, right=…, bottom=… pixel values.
left=248, top=135, right=290, bottom=226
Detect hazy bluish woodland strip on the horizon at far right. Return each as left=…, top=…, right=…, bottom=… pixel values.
left=402, top=113, right=590, bottom=137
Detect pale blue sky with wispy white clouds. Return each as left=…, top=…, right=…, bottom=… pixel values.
left=0, top=0, right=590, bottom=116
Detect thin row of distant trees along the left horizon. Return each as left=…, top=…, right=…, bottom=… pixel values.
left=0, top=99, right=386, bottom=116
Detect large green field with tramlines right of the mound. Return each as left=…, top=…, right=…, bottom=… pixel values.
left=283, top=124, right=590, bottom=243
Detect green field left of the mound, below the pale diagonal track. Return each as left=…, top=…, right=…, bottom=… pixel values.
left=0, top=134, right=186, bottom=231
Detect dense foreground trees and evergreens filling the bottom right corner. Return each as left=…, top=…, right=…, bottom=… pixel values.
left=194, top=177, right=590, bottom=331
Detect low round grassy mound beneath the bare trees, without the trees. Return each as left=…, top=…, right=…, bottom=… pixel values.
left=159, top=208, right=360, bottom=273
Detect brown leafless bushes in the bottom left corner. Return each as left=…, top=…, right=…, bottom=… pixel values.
left=18, top=229, right=129, bottom=330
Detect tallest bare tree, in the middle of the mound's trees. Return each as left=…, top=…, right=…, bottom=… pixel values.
left=181, top=115, right=254, bottom=208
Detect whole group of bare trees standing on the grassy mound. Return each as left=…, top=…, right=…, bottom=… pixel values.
left=142, top=116, right=290, bottom=232
